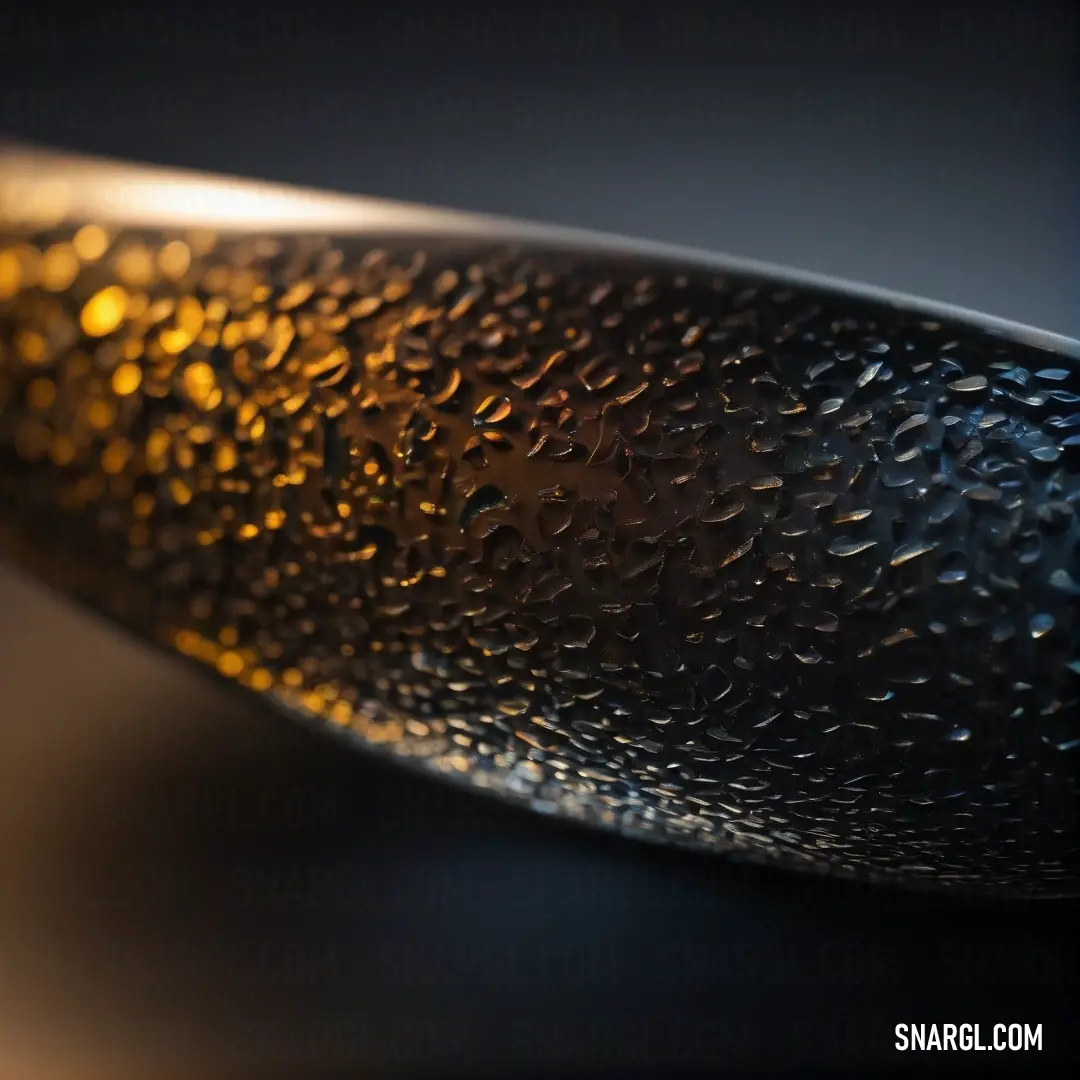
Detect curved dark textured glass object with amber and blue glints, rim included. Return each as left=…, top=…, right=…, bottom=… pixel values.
left=0, top=150, right=1080, bottom=894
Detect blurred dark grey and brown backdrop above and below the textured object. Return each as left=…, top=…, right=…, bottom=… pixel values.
left=0, top=2, right=1080, bottom=1080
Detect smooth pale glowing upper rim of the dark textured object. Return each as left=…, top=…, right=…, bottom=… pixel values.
left=0, top=140, right=1080, bottom=360
